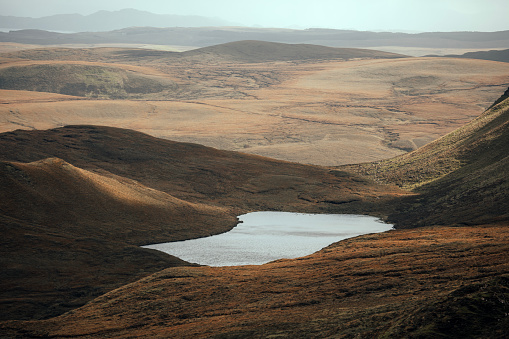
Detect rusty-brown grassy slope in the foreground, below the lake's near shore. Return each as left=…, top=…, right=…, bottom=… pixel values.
left=0, top=227, right=509, bottom=338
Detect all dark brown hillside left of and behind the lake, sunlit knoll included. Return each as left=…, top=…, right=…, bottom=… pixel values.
left=0, top=126, right=404, bottom=320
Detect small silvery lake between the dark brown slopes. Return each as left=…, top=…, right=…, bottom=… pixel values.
left=143, top=212, right=393, bottom=266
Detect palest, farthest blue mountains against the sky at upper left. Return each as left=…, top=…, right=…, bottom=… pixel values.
left=0, top=9, right=233, bottom=32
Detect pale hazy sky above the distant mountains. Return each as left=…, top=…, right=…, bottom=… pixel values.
left=0, top=0, right=509, bottom=31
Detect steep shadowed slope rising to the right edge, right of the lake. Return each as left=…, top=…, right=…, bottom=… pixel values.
left=347, top=90, right=509, bottom=227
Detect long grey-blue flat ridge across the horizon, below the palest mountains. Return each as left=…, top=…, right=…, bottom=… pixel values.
left=0, top=24, right=509, bottom=49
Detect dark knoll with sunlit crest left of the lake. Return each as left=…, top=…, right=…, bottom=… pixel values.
left=0, top=158, right=236, bottom=319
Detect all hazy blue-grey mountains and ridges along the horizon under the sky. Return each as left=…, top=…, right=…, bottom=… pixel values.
left=0, top=9, right=509, bottom=50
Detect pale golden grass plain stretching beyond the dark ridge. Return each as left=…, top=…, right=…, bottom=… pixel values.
left=0, top=49, right=509, bottom=165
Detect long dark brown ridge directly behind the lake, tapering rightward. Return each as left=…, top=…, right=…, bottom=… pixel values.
left=0, top=126, right=405, bottom=212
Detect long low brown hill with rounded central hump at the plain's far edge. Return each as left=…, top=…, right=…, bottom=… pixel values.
left=0, top=40, right=406, bottom=64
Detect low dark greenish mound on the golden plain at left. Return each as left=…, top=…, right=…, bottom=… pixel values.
left=0, top=64, right=175, bottom=98
